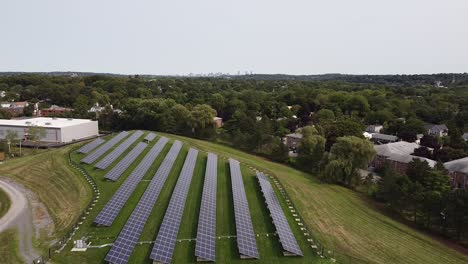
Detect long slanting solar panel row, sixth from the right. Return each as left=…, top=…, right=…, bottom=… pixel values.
left=94, top=137, right=168, bottom=226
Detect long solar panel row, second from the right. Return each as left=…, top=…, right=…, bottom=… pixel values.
left=229, top=159, right=259, bottom=259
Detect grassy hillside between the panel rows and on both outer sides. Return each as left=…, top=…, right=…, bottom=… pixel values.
left=0, top=133, right=468, bottom=263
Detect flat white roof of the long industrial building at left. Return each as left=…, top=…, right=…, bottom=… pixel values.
left=0, top=117, right=97, bottom=128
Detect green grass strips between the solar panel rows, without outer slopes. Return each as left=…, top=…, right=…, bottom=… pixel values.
left=53, top=133, right=327, bottom=263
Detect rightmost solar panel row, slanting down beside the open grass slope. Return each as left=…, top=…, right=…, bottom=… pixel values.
left=257, top=171, right=302, bottom=256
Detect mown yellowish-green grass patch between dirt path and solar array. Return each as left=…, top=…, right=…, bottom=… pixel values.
left=0, top=145, right=91, bottom=239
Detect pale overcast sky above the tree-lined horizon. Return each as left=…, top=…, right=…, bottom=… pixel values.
left=0, top=0, right=468, bottom=74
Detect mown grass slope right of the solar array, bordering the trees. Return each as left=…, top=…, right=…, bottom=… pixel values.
left=164, top=135, right=468, bottom=264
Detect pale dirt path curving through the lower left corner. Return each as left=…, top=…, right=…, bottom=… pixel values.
left=0, top=178, right=39, bottom=263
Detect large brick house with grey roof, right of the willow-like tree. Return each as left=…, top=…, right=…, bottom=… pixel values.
left=371, top=141, right=436, bottom=174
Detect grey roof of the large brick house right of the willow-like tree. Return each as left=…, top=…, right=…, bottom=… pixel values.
left=374, top=141, right=436, bottom=167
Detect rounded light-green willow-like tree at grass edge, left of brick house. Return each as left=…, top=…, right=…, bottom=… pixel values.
left=322, top=136, right=376, bottom=187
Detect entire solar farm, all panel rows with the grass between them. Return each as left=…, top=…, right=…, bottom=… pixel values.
left=57, top=131, right=329, bottom=263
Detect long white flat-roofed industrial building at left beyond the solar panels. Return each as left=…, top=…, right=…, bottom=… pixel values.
left=0, top=117, right=99, bottom=143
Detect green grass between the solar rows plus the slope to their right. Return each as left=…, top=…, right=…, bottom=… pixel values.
left=49, top=133, right=468, bottom=263
